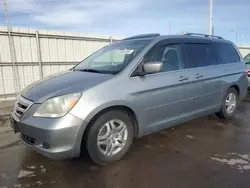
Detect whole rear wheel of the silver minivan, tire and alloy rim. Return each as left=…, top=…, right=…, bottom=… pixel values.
left=216, top=88, right=239, bottom=119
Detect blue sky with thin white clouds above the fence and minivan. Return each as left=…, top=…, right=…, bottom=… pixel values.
left=0, top=0, right=250, bottom=45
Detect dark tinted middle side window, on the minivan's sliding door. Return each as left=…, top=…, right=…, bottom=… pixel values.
left=183, top=43, right=216, bottom=68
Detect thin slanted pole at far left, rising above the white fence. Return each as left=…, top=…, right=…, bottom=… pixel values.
left=4, top=0, right=19, bottom=95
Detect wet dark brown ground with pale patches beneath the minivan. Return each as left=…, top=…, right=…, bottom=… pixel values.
left=0, top=100, right=250, bottom=188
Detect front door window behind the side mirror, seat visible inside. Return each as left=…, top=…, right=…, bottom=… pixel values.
left=143, top=44, right=184, bottom=72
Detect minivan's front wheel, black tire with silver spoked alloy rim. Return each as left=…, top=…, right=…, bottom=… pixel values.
left=86, top=110, right=134, bottom=165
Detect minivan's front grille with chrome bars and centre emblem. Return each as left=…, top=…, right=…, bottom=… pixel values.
left=14, top=96, right=33, bottom=117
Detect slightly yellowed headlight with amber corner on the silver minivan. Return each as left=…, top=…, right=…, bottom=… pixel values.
left=34, top=93, right=81, bottom=117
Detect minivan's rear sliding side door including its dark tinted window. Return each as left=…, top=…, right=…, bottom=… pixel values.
left=183, top=40, right=222, bottom=115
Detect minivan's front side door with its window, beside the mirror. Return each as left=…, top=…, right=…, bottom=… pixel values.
left=131, top=40, right=205, bottom=134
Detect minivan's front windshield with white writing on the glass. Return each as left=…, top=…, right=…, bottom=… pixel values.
left=74, top=39, right=151, bottom=74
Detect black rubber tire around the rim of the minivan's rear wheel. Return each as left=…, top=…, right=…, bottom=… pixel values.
left=216, top=88, right=239, bottom=119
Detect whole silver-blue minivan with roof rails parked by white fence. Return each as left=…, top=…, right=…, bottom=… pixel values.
left=10, top=33, right=248, bottom=164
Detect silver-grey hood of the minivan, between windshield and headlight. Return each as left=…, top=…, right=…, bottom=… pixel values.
left=21, top=71, right=114, bottom=103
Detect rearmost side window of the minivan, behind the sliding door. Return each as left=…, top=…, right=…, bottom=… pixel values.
left=215, top=43, right=240, bottom=64
